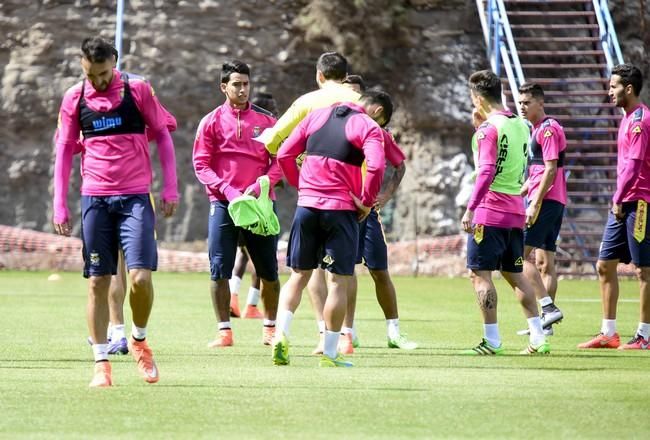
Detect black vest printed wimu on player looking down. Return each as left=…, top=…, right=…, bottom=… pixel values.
left=79, top=73, right=145, bottom=139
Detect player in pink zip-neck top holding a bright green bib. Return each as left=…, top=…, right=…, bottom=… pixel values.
left=192, top=60, right=282, bottom=348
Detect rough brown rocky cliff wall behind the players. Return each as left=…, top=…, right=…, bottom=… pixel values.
left=0, top=0, right=650, bottom=241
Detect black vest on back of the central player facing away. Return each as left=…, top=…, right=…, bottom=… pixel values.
left=307, top=105, right=365, bottom=167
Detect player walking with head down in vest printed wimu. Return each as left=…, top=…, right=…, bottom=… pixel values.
left=53, top=37, right=178, bottom=387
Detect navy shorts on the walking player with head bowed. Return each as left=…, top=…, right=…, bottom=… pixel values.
left=81, top=194, right=158, bottom=278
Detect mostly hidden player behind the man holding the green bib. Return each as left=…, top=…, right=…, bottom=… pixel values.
left=228, top=92, right=281, bottom=319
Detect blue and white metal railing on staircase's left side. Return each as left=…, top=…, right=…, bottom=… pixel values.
left=476, top=0, right=526, bottom=111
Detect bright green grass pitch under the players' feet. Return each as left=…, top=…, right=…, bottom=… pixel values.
left=0, top=272, right=650, bottom=439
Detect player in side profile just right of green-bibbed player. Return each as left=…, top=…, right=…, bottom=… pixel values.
left=519, top=83, right=567, bottom=335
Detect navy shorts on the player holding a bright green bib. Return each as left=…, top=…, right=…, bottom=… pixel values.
left=208, top=201, right=278, bottom=281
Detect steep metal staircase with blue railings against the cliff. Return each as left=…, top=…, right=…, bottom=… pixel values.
left=476, top=0, right=623, bottom=275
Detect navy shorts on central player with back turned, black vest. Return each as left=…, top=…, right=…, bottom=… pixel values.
left=287, top=206, right=359, bottom=275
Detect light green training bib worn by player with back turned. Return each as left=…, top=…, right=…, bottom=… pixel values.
left=472, top=114, right=530, bottom=194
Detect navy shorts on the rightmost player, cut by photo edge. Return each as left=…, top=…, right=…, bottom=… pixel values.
left=598, top=202, right=650, bottom=267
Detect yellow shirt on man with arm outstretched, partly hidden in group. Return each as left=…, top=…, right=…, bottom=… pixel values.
left=266, top=81, right=361, bottom=155
